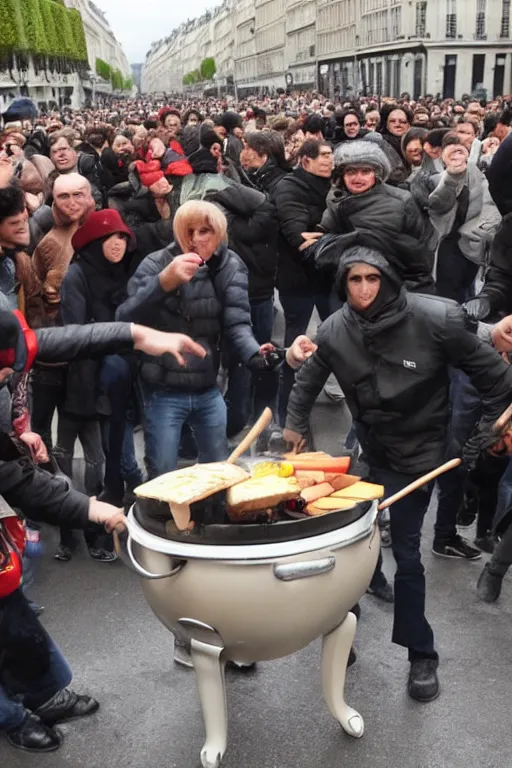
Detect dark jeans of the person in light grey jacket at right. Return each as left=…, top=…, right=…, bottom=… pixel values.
left=436, top=236, right=478, bottom=304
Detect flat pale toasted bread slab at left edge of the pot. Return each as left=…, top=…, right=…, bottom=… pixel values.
left=135, top=461, right=249, bottom=504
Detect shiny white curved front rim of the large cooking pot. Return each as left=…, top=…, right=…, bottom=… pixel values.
left=126, top=501, right=378, bottom=565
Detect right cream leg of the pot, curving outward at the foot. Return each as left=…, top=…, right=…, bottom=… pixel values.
left=322, top=613, right=364, bottom=739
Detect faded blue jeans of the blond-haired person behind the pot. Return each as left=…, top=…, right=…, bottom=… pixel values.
left=141, top=384, right=229, bottom=478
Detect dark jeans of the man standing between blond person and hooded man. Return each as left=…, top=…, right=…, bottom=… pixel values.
left=278, top=293, right=331, bottom=427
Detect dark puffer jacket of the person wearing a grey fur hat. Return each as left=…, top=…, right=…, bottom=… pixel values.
left=313, top=184, right=434, bottom=293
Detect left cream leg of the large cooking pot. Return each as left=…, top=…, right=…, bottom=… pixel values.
left=190, top=639, right=228, bottom=768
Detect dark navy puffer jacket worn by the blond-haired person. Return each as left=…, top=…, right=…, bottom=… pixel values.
left=116, top=243, right=259, bottom=392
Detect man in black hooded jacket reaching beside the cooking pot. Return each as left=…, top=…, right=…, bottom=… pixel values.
left=283, top=246, right=512, bottom=701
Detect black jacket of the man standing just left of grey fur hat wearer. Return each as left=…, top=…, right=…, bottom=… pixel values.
left=274, top=168, right=330, bottom=296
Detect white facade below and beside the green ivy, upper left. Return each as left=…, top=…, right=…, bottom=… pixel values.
left=0, top=0, right=131, bottom=111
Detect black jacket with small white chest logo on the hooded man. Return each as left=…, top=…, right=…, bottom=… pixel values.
left=286, top=254, right=512, bottom=475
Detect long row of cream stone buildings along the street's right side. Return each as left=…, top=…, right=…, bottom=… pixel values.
left=142, top=0, right=512, bottom=98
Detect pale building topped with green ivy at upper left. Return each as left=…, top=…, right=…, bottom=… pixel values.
left=0, top=0, right=132, bottom=110
